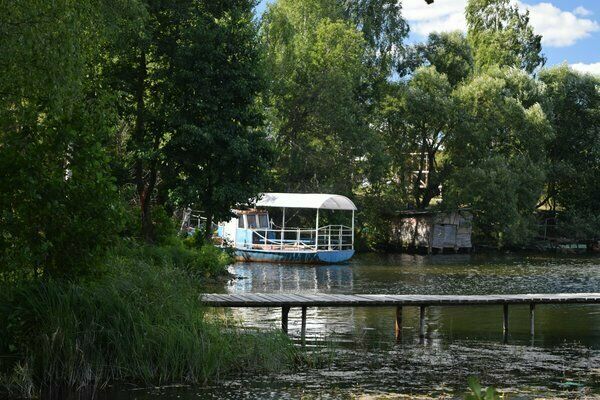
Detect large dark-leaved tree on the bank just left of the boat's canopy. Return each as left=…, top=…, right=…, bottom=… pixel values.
left=108, top=0, right=268, bottom=242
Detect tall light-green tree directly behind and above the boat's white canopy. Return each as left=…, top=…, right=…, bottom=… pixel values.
left=262, top=0, right=373, bottom=194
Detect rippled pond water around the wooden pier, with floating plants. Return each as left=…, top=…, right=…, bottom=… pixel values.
left=106, top=254, right=600, bottom=399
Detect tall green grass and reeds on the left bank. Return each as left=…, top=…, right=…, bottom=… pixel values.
left=0, top=244, right=296, bottom=398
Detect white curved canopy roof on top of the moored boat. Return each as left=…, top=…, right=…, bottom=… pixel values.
left=256, top=193, right=356, bottom=210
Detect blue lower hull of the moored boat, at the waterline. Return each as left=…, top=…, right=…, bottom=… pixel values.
left=235, top=249, right=354, bottom=264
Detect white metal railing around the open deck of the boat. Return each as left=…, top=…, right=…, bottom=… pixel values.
left=246, top=225, right=354, bottom=251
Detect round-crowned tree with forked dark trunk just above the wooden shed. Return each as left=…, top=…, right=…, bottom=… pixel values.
left=382, top=66, right=456, bottom=209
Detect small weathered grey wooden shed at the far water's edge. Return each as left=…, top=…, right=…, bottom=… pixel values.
left=391, top=210, right=473, bottom=253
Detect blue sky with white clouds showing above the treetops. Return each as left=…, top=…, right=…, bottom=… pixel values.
left=257, top=0, right=600, bottom=75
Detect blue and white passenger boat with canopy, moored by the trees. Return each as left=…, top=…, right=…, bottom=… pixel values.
left=217, top=193, right=356, bottom=264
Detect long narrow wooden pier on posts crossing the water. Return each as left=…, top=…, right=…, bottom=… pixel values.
left=202, top=293, right=600, bottom=339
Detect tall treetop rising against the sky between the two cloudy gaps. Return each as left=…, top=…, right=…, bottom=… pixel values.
left=465, top=0, right=546, bottom=73
